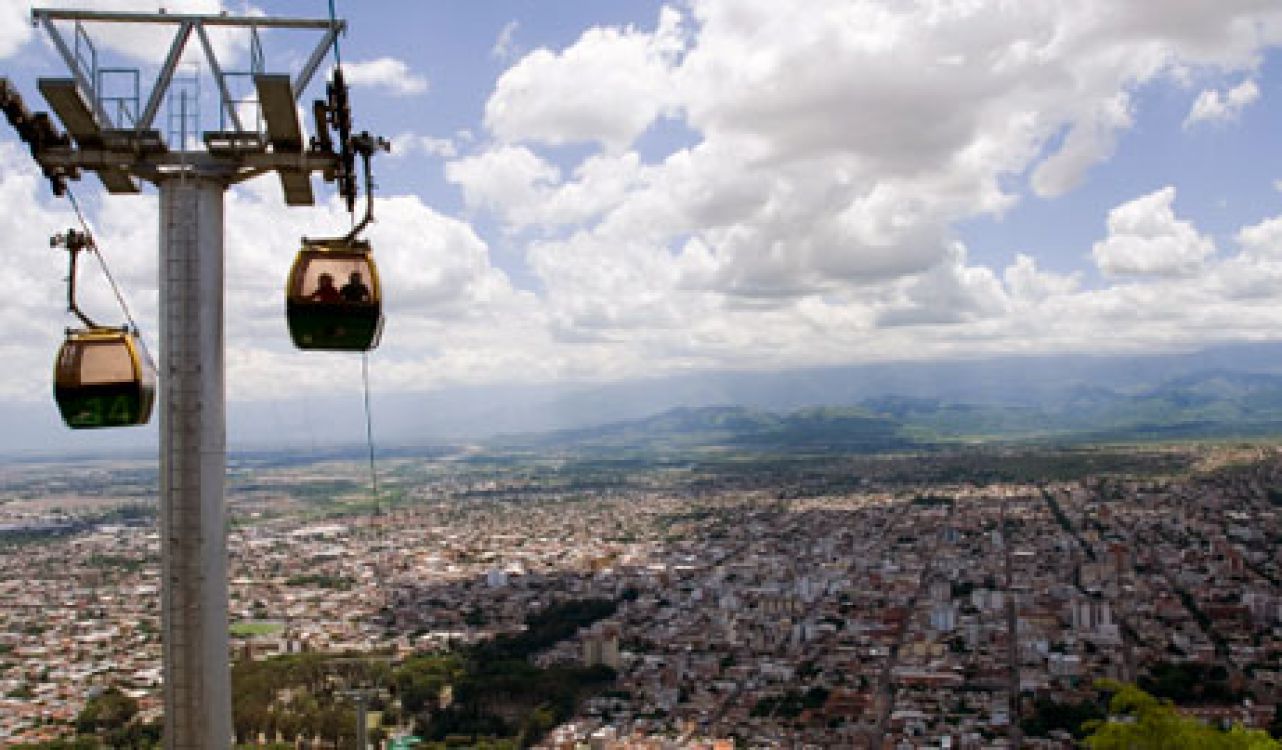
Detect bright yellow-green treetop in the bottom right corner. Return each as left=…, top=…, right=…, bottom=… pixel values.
left=1086, top=679, right=1282, bottom=750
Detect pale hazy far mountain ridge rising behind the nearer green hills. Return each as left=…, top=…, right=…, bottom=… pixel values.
left=358, top=344, right=1282, bottom=451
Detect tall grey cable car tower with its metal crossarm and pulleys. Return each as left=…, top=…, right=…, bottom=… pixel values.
left=0, top=9, right=383, bottom=749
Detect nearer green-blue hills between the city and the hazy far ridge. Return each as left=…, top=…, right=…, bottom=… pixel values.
left=487, top=372, right=1282, bottom=453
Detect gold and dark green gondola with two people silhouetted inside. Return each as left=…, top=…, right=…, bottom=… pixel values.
left=285, top=237, right=383, bottom=351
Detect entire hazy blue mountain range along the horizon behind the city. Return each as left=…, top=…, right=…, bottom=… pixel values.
left=12, top=344, right=1282, bottom=455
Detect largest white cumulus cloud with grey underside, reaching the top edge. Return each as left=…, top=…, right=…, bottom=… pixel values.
left=466, top=0, right=1282, bottom=324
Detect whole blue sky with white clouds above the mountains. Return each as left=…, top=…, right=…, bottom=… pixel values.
left=0, top=0, right=1282, bottom=443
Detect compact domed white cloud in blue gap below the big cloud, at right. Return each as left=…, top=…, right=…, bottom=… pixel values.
left=1091, top=186, right=1215, bottom=276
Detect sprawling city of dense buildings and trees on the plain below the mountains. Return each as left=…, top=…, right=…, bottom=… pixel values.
left=0, top=442, right=1282, bottom=749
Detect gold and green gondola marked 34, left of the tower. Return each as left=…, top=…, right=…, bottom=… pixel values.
left=54, top=326, right=155, bottom=429
